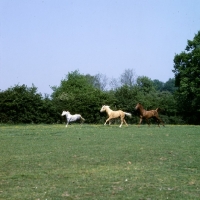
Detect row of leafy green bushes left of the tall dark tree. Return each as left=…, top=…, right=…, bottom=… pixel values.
left=0, top=71, right=186, bottom=124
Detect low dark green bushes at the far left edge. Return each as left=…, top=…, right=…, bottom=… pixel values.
left=0, top=85, right=56, bottom=123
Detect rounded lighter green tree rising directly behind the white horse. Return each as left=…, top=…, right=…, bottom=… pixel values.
left=52, top=70, right=107, bottom=123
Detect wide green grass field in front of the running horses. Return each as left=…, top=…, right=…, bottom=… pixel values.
left=0, top=124, right=200, bottom=200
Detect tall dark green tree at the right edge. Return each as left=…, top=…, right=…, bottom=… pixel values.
left=173, top=31, right=200, bottom=124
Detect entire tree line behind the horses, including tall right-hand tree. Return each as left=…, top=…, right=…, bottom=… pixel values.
left=0, top=31, right=200, bottom=124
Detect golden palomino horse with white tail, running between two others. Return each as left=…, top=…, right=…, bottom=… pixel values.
left=100, top=105, right=132, bottom=127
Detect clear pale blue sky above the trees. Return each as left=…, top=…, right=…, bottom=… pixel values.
left=0, top=0, right=200, bottom=94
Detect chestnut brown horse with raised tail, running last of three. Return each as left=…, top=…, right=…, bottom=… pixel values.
left=135, top=103, right=165, bottom=127
